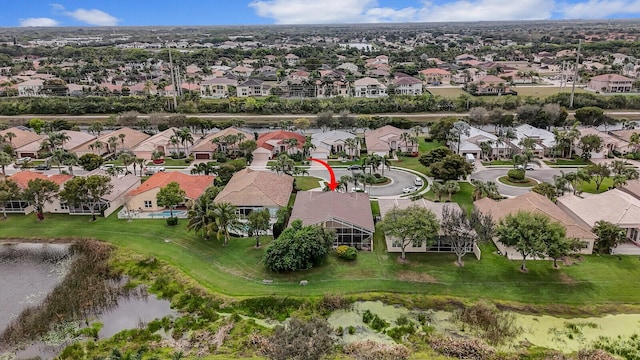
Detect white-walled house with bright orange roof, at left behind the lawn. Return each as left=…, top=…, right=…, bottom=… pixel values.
left=127, top=171, right=215, bottom=212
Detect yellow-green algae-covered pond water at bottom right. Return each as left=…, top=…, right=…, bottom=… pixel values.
left=328, top=301, right=640, bottom=353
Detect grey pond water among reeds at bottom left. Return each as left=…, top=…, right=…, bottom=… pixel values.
left=0, top=243, right=178, bottom=359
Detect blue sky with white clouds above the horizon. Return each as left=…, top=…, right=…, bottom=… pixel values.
left=0, top=0, right=640, bottom=27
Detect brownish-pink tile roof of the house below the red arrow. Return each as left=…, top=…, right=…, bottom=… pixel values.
left=290, top=191, right=375, bottom=232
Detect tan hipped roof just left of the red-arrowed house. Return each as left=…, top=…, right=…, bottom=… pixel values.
left=215, top=168, right=293, bottom=207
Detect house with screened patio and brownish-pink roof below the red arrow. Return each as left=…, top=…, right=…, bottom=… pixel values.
left=289, top=191, right=375, bottom=251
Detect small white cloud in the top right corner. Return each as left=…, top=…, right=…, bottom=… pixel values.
left=560, top=0, right=640, bottom=19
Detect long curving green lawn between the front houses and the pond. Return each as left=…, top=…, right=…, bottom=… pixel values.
left=0, top=212, right=640, bottom=311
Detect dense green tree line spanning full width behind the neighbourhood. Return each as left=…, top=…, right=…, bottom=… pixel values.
left=0, top=93, right=640, bottom=115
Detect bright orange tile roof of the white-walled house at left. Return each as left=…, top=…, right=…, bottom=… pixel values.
left=129, top=171, right=215, bottom=199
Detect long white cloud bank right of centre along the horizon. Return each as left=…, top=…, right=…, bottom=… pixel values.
left=249, top=0, right=556, bottom=24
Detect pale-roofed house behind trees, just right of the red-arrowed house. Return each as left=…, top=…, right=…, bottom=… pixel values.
left=378, top=198, right=480, bottom=255
